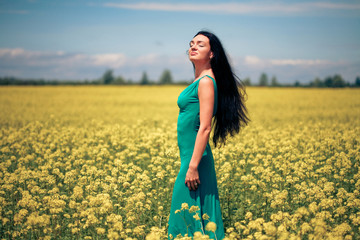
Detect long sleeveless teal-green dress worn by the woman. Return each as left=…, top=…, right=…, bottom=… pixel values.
left=168, top=75, right=224, bottom=239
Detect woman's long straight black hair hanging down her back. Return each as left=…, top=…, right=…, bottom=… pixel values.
left=194, top=31, right=250, bottom=147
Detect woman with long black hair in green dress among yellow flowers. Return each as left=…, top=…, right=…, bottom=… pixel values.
left=168, top=31, right=249, bottom=239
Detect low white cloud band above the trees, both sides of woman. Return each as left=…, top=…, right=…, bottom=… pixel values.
left=0, top=48, right=360, bottom=83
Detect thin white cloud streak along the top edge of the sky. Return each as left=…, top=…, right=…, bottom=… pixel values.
left=104, top=1, right=360, bottom=14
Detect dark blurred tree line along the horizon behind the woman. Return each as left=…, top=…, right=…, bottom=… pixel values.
left=0, top=69, right=360, bottom=88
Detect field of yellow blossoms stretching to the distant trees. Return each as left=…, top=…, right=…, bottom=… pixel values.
left=0, top=86, right=360, bottom=240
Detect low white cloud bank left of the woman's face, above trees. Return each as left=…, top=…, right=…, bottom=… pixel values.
left=0, top=48, right=192, bottom=80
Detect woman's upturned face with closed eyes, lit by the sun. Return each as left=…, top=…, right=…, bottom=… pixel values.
left=189, top=34, right=213, bottom=63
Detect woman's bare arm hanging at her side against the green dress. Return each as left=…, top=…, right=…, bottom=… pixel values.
left=185, top=77, right=214, bottom=190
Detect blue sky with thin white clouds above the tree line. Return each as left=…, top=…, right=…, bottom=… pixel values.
left=0, top=0, right=360, bottom=83
